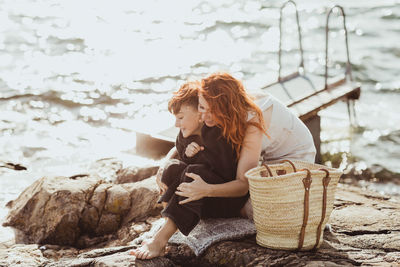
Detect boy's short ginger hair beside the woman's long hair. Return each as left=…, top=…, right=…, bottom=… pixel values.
left=168, top=81, right=201, bottom=115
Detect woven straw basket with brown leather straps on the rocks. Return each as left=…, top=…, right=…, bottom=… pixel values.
left=245, top=160, right=342, bottom=250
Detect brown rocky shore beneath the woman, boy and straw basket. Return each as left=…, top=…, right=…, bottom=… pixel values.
left=0, top=159, right=400, bottom=267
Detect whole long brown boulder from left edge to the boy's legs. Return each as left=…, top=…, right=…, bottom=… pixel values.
left=3, top=176, right=159, bottom=247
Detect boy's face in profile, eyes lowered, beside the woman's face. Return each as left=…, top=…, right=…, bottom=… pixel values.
left=175, top=104, right=203, bottom=138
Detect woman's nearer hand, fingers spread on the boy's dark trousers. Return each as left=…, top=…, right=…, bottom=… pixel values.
left=175, top=172, right=208, bottom=204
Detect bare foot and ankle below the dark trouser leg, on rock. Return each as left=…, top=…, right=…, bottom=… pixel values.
left=130, top=218, right=177, bottom=260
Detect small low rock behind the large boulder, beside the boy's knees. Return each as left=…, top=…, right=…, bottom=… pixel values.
left=115, top=166, right=159, bottom=184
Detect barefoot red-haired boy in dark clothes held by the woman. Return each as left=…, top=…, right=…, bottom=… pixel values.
left=130, top=82, right=248, bottom=259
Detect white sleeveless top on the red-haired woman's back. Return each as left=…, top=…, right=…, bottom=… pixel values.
left=248, top=95, right=316, bottom=162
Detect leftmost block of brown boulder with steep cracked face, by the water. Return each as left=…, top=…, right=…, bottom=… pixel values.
left=3, top=177, right=99, bottom=245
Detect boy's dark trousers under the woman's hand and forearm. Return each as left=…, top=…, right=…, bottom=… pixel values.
left=160, top=161, right=249, bottom=235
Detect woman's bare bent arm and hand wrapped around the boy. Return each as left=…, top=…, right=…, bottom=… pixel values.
left=176, top=122, right=263, bottom=204
